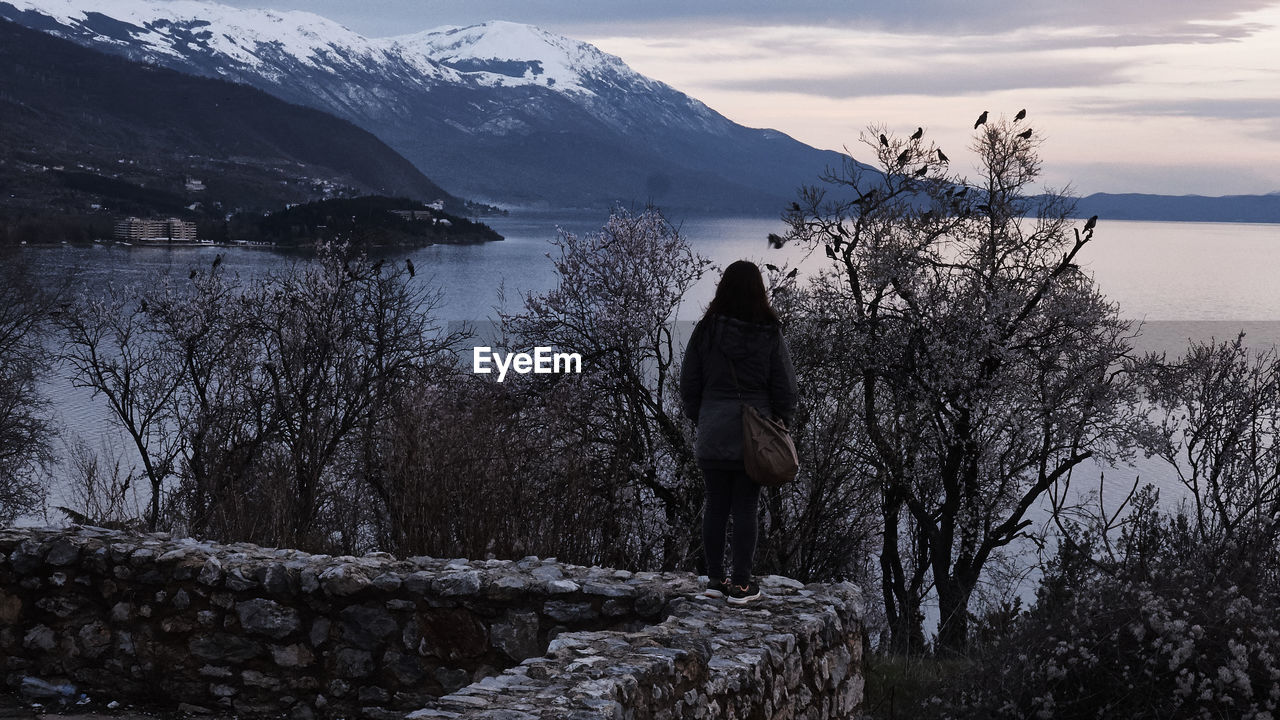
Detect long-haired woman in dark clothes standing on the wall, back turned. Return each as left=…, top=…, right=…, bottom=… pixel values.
left=680, top=260, right=796, bottom=605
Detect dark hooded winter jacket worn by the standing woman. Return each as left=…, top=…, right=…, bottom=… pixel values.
left=680, top=314, right=796, bottom=468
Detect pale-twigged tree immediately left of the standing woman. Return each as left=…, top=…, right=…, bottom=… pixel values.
left=503, top=208, right=710, bottom=568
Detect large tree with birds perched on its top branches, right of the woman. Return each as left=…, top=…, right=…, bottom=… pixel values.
left=787, top=113, right=1133, bottom=650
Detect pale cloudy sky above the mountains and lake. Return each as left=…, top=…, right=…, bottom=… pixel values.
left=221, top=0, right=1280, bottom=195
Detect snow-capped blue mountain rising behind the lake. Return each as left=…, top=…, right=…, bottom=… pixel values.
left=0, top=0, right=840, bottom=213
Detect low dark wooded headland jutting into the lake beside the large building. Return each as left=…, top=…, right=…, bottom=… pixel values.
left=227, top=196, right=502, bottom=247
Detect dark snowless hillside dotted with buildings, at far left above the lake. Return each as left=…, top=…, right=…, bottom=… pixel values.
left=0, top=20, right=466, bottom=240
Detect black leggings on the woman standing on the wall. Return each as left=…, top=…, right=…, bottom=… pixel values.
left=703, top=468, right=760, bottom=585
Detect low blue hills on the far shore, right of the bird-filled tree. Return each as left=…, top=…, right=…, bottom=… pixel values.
left=1076, top=192, right=1280, bottom=223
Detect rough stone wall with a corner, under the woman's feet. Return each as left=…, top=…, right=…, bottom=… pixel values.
left=0, top=525, right=863, bottom=720
